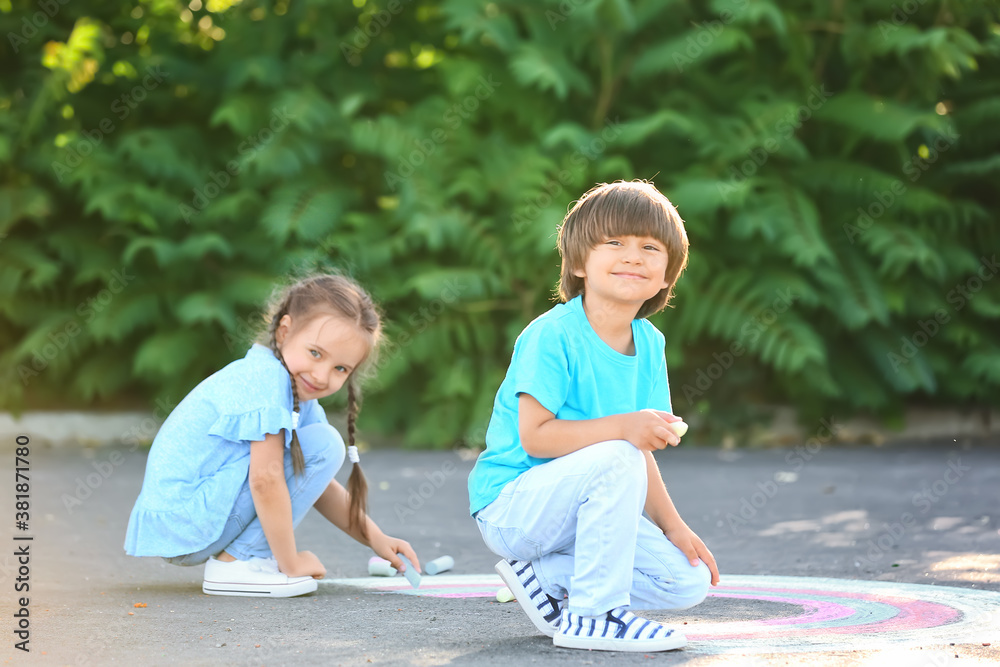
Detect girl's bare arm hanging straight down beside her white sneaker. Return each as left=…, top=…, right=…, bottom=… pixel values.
left=250, top=433, right=326, bottom=577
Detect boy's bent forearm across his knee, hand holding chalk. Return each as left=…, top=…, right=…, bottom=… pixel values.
left=517, top=393, right=680, bottom=459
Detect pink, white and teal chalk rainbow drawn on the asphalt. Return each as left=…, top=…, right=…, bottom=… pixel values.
left=321, top=574, right=1000, bottom=654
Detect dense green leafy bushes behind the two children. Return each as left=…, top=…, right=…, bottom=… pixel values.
left=0, top=0, right=1000, bottom=447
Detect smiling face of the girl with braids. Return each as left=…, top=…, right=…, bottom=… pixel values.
left=274, top=314, right=368, bottom=401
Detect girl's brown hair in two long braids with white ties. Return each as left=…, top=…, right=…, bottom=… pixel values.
left=265, top=274, right=382, bottom=534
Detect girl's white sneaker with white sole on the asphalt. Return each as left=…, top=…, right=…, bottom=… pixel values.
left=207, top=558, right=317, bottom=598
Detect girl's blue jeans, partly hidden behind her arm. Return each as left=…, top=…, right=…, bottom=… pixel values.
left=164, top=423, right=347, bottom=565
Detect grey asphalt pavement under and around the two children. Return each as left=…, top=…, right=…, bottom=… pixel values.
left=0, top=439, right=1000, bottom=667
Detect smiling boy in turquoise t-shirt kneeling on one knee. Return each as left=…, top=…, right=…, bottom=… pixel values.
left=469, top=181, right=719, bottom=652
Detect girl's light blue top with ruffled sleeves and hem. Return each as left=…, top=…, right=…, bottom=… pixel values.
left=125, top=345, right=326, bottom=558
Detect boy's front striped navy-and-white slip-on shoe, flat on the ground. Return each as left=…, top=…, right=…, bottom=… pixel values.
left=552, top=607, right=687, bottom=652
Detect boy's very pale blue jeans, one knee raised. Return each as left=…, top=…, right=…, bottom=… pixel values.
left=476, top=440, right=711, bottom=616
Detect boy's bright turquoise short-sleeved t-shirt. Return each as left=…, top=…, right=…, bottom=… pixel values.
left=469, top=296, right=670, bottom=514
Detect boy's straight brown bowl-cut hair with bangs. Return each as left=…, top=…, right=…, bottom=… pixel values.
left=558, top=181, right=688, bottom=318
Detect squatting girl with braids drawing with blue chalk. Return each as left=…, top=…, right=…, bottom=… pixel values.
left=125, top=275, right=420, bottom=597
